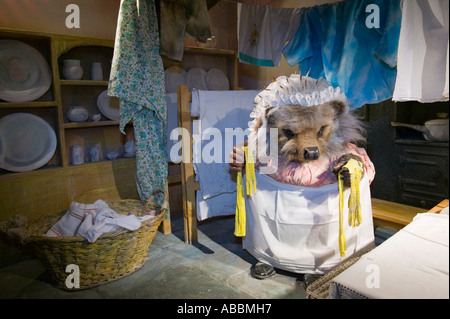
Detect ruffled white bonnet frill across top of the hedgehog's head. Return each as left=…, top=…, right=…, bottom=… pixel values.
left=248, top=74, right=346, bottom=131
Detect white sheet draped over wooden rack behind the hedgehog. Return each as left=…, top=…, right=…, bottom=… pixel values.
left=191, top=90, right=260, bottom=220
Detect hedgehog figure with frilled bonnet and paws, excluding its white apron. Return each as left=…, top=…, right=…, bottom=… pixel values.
left=230, top=75, right=375, bottom=279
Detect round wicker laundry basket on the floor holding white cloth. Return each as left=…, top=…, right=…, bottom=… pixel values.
left=5, top=193, right=168, bottom=291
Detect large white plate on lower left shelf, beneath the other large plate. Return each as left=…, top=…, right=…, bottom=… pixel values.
left=0, top=113, right=56, bottom=172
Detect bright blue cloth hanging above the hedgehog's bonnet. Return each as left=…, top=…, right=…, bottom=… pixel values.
left=283, top=0, right=401, bottom=108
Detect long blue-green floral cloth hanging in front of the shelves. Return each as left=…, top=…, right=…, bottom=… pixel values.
left=108, top=0, right=168, bottom=204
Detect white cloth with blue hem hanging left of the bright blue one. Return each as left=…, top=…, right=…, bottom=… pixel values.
left=238, top=3, right=301, bottom=67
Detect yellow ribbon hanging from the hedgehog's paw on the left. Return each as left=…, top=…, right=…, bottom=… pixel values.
left=234, top=147, right=256, bottom=237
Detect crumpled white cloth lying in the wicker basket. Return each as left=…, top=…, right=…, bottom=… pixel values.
left=44, top=199, right=152, bottom=243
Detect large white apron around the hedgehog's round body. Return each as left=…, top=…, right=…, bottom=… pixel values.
left=243, top=171, right=374, bottom=274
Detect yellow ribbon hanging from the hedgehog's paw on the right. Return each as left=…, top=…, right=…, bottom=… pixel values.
left=338, top=159, right=363, bottom=257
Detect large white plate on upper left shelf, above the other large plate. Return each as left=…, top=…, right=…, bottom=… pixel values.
left=0, top=40, right=52, bottom=102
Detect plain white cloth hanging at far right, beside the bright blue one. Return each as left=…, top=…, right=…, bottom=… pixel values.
left=393, top=0, right=449, bottom=103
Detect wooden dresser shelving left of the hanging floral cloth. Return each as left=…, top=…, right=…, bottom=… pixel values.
left=0, top=28, right=139, bottom=220
